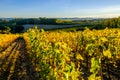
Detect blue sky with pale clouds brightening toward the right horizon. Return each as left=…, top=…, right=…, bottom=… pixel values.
left=0, top=0, right=120, bottom=18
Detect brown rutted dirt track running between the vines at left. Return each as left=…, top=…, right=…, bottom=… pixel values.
left=0, top=38, right=38, bottom=80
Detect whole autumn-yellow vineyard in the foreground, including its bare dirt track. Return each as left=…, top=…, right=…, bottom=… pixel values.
left=0, top=27, right=120, bottom=80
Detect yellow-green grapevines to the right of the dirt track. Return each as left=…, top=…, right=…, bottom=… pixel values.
left=24, top=27, right=120, bottom=80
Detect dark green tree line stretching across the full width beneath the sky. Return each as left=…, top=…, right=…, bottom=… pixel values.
left=0, top=17, right=120, bottom=33
